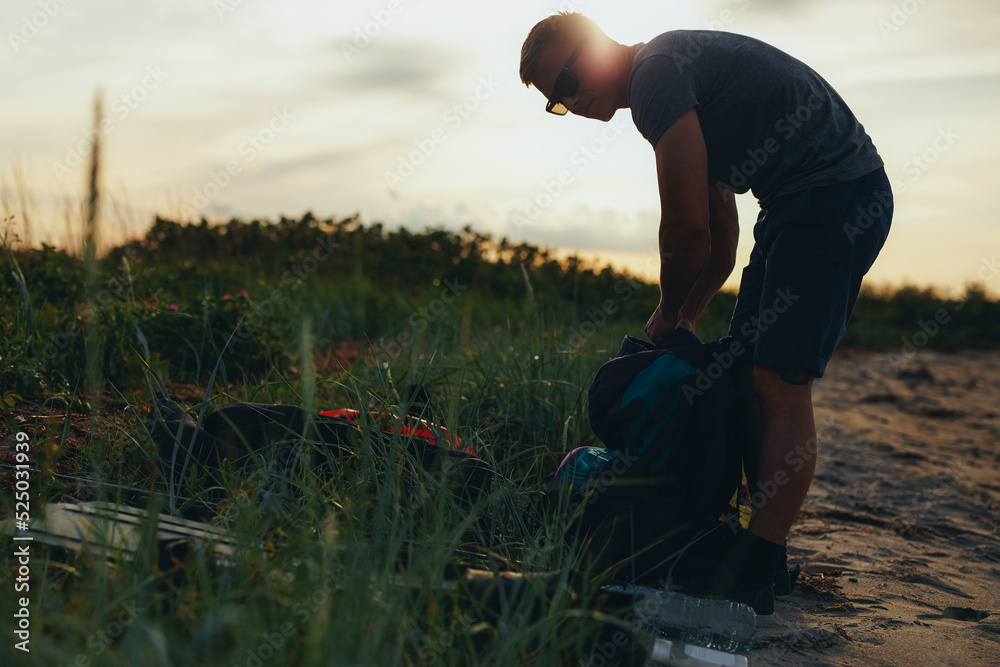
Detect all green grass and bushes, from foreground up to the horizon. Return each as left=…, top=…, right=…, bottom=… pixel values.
left=0, top=215, right=1000, bottom=665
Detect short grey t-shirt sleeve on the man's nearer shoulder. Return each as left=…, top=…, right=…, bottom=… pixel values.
left=628, top=54, right=698, bottom=148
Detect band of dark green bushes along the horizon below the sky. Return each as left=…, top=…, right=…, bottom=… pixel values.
left=0, top=214, right=1000, bottom=397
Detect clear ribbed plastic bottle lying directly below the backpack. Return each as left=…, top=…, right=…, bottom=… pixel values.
left=605, top=585, right=757, bottom=653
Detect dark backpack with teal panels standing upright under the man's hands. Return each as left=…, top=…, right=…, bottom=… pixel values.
left=555, top=330, right=753, bottom=583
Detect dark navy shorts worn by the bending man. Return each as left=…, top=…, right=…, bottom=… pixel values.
left=729, top=167, right=893, bottom=382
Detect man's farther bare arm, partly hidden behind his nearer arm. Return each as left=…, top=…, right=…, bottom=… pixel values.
left=677, top=187, right=740, bottom=331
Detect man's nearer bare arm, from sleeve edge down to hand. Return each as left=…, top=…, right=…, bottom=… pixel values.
left=646, top=108, right=712, bottom=342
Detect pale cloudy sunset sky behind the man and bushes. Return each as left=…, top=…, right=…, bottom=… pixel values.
left=0, top=0, right=1000, bottom=294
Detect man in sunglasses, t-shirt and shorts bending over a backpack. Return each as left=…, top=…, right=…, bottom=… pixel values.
left=520, top=12, right=893, bottom=616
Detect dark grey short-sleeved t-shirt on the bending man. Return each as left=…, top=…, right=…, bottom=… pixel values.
left=628, top=30, right=883, bottom=204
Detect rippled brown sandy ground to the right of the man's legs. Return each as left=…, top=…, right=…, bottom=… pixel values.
left=750, top=351, right=1000, bottom=667
